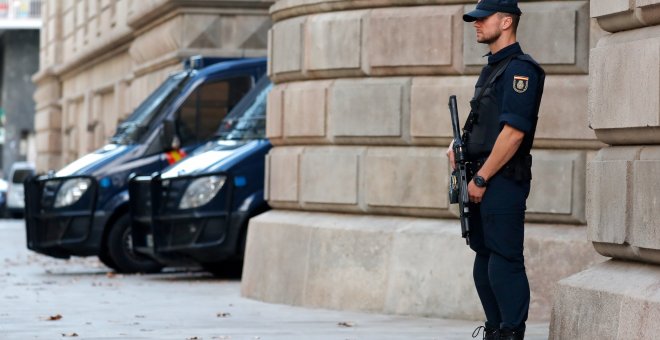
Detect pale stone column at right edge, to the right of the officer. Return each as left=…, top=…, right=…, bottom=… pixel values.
left=550, top=0, right=660, bottom=339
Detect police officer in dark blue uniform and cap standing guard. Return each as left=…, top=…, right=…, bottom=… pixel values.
left=447, top=0, right=545, bottom=340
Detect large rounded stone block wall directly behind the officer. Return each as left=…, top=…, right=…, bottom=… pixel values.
left=242, top=0, right=602, bottom=320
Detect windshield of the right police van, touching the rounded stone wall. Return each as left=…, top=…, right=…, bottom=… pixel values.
left=216, top=77, right=273, bottom=140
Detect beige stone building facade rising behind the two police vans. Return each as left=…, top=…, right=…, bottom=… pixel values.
left=33, top=0, right=273, bottom=171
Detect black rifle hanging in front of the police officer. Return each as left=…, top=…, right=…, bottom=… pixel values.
left=449, top=95, right=470, bottom=245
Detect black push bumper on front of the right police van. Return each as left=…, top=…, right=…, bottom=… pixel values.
left=131, top=172, right=242, bottom=263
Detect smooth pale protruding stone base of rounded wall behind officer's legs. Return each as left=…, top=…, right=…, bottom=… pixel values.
left=241, top=210, right=604, bottom=321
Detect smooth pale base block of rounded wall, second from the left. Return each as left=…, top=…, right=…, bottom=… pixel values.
left=303, top=218, right=397, bottom=312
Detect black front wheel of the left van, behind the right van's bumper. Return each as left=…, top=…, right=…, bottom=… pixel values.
left=107, top=214, right=163, bottom=274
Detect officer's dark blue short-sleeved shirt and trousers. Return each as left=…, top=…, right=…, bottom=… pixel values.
left=467, top=43, right=545, bottom=330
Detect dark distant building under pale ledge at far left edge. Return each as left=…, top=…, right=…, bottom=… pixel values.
left=2, top=30, right=39, bottom=176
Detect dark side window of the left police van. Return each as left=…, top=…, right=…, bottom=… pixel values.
left=176, top=76, right=252, bottom=146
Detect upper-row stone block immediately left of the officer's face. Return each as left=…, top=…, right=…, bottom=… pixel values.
left=365, top=6, right=463, bottom=71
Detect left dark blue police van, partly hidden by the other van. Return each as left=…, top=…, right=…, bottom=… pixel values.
left=25, top=58, right=266, bottom=273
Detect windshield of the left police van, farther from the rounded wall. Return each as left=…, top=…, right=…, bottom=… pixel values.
left=110, top=72, right=190, bottom=144
